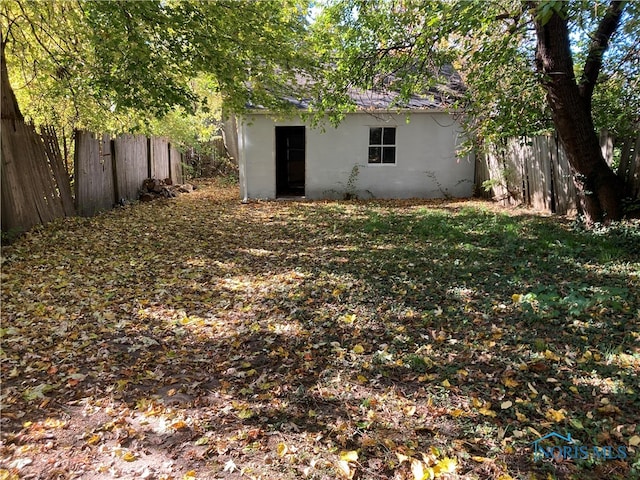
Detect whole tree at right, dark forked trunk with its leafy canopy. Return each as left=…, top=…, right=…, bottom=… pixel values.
left=314, top=0, right=640, bottom=221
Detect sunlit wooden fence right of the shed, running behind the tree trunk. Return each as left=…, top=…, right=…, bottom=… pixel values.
left=476, top=133, right=640, bottom=214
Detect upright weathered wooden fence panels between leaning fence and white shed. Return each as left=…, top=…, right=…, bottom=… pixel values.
left=74, top=131, right=183, bottom=216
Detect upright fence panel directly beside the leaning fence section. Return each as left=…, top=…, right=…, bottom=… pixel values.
left=74, top=131, right=116, bottom=216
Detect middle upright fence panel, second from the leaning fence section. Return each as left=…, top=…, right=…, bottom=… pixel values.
left=113, top=135, right=149, bottom=201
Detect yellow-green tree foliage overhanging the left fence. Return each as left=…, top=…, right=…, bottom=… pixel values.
left=1, top=0, right=307, bottom=137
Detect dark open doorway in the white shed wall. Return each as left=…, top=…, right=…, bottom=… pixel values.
left=276, top=127, right=305, bottom=197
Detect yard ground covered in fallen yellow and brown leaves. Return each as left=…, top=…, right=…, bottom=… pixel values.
left=0, top=182, right=640, bottom=480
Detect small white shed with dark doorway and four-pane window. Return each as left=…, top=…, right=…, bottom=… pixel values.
left=237, top=78, right=475, bottom=200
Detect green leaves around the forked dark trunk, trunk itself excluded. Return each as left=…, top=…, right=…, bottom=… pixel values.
left=314, top=0, right=640, bottom=139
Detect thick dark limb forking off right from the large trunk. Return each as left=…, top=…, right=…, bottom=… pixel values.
left=579, top=0, right=627, bottom=102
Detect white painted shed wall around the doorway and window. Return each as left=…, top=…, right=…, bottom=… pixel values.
left=239, top=112, right=475, bottom=199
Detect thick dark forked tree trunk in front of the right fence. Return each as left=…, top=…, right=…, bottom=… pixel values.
left=533, top=2, right=623, bottom=223
